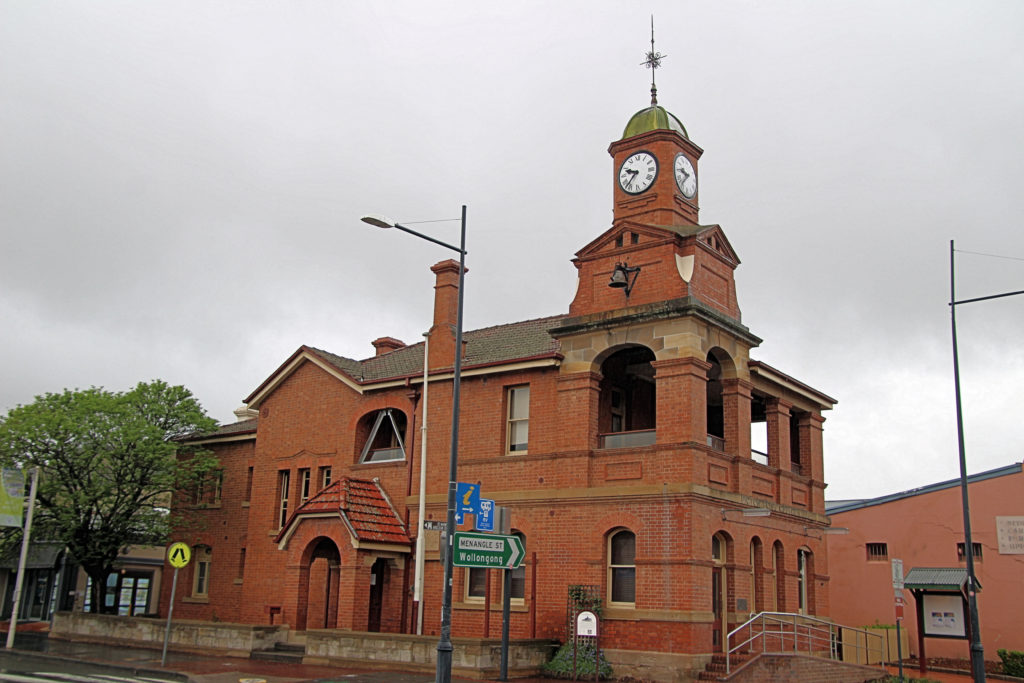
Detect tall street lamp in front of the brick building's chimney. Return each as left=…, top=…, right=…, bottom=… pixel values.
left=361, top=204, right=466, bottom=683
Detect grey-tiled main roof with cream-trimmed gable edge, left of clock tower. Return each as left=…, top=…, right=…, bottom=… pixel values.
left=245, top=315, right=565, bottom=408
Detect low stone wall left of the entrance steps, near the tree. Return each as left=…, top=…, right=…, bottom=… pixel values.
left=50, top=612, right=288, bottom=657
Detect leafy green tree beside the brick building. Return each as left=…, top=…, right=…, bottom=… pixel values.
left=0, top=380, right=217, bottom=611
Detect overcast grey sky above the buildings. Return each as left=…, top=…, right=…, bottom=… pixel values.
left=0, top=0, right=1024, bottom=500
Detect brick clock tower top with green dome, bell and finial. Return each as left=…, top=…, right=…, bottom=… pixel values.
left=569, top=34, right=749, bottom=325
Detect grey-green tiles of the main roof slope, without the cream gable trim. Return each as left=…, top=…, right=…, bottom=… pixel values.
left=311, top=315, right=565, bottom=382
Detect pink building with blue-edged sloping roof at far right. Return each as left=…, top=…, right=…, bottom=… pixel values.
left=826, top=463, right=1024, bottom=660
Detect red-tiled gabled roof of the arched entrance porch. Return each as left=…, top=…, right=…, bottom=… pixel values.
left=274, top=477, right=412, bottom=549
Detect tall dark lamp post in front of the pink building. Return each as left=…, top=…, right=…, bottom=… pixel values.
left=949, top=240, right=1024, bottom=683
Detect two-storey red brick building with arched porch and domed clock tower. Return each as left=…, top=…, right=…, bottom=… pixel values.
left=163, top=93, right=835, bottom=672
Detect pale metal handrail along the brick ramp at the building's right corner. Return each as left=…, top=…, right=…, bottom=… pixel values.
left=725, top=612, right=885, bottom=674
